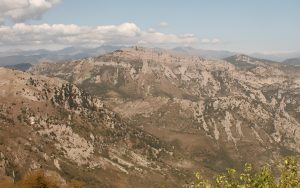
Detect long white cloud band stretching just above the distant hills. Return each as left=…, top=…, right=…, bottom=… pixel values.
left=0, top=23, right=220, bottom=49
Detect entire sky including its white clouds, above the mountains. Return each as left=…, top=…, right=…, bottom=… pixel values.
left=0, top=0, right=300, bottom=53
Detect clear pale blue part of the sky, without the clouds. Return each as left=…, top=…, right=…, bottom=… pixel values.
left=0, top=0, right=300, bottom=53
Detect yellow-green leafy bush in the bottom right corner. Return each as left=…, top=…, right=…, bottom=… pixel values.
left=188, top=157, right=300, bottom=188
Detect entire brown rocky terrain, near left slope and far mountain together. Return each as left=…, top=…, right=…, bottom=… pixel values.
left=0, top=47, right=300, bottom=187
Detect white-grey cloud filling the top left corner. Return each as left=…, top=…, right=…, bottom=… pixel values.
left=0, top=0, right=62, bottom=23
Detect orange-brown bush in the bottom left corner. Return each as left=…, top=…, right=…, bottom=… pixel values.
left=0, top=170, right=85, bottom=188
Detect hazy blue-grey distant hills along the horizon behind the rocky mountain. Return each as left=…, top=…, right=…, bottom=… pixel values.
left=0, top=46, right=300, bottom=66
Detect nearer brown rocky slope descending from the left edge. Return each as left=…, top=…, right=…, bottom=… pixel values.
left=0, top=68, right=193, bottom=187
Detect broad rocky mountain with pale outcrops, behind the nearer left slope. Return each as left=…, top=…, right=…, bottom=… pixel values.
left=30, top=47, right=300, bottom=182
